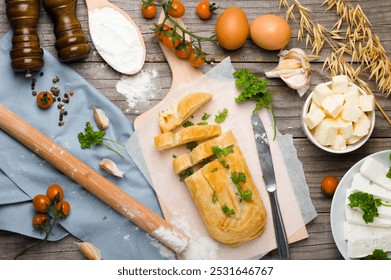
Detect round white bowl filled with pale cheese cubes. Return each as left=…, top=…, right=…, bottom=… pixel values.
left=301, top=75, right=375, bottom=154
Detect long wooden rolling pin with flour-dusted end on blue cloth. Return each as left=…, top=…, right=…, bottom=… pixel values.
left=0, top=104, right=189, bottom=253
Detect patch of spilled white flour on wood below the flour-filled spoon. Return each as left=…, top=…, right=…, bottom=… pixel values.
left=116, top=70, right=157, bottom=108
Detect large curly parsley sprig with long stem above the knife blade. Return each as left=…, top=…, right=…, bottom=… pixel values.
left=233, top=69, right=277, bottom=138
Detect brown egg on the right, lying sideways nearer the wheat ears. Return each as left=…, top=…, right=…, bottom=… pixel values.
left=250, top=14, right=291, bottom=51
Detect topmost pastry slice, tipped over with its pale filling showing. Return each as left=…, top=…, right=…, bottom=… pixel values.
left=159, top=92, right=212, bottom=133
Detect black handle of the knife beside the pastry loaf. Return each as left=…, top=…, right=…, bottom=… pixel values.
left=269, top=191, right=289, bottom=260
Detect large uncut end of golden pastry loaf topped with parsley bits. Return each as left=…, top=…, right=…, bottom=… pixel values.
left=185, top=146, right=267, bottom=246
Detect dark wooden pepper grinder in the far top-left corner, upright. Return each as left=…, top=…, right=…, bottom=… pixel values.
left=5, top=0, right=43, bottom=74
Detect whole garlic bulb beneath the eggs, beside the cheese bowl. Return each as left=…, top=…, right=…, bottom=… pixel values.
left=265, top=48, right=311, bottom=97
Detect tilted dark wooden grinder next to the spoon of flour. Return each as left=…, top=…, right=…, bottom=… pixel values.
left=42, top=0, right=90, bottom=62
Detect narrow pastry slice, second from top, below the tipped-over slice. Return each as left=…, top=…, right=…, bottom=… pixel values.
left=154, top=124, right=221, bottom=151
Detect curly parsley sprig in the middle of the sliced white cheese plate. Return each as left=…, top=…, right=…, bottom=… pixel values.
left=348, top=192, right=391, bottom=224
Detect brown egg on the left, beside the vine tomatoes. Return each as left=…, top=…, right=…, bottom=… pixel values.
left=216, top=7, right=250, bottom=50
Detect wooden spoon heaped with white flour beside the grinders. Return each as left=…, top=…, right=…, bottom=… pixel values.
left=85, top=0, right=146, bottom=75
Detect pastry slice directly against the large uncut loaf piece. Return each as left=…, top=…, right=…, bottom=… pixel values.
left=172, top=130, right=236, bottom=174
